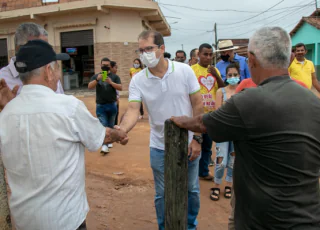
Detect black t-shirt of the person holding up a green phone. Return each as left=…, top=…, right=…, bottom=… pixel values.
left=90, top=73, right=121, bottom=104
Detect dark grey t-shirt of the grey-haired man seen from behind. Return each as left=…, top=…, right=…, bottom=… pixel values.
left=203, top=76, right=320, bottom=230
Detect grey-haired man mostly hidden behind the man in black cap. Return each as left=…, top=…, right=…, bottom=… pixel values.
left=0, top=22, right=64, bottom=94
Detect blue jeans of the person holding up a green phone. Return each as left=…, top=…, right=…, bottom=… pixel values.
left=96, top=102, right=118, bottom=128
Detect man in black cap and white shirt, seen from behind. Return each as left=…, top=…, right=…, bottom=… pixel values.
left=0, top=40, right=127, bottom=230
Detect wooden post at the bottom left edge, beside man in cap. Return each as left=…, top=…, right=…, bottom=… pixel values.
left=0, top=156, right=12, bottom=230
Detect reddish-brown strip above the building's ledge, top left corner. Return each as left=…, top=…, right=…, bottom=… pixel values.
left=0, top=0, right=81, bottom=12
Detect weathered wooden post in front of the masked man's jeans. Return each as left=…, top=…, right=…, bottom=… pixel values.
left=164, top=120, right=188, bottom=230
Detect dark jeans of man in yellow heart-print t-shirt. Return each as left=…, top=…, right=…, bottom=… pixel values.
left=199, top=134, right=212, bottom=177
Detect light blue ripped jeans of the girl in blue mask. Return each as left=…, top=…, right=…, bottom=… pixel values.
left=214, top=141, right=235, bottom=184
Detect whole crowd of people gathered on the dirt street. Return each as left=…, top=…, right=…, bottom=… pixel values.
left=0, top=23, right=320, bottom=230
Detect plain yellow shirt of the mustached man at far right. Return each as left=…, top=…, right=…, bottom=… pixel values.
left=288, top=58, right=315, bottom=89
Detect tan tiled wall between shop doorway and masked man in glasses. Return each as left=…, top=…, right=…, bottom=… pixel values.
left=94, top=42, right=138, bottom=91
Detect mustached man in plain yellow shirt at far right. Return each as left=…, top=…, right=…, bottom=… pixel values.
left=288, top=43, right=320, bottom=92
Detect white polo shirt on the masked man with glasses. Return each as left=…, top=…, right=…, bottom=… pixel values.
left=129, top=59, right=200, bottom=150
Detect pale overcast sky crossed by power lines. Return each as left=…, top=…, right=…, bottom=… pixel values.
left=156, top=0, right=320, bottom=58
